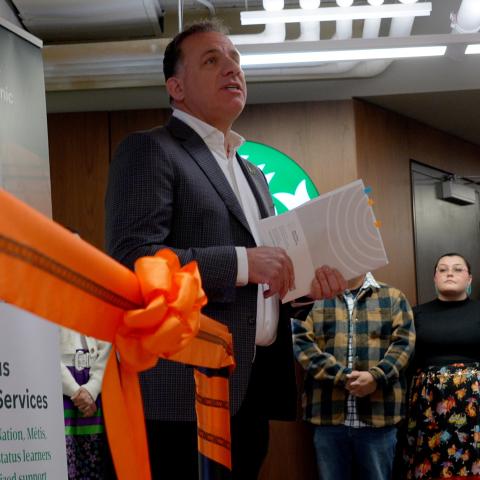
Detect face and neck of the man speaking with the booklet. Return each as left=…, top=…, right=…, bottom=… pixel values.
left=167, top=32, right=247, bottom=133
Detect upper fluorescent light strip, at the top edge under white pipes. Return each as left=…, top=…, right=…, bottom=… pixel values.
left=240, top=2, right=432, bottom=25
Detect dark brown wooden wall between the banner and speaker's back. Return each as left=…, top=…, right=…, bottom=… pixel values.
left=48, top=112, right=110, bottom=249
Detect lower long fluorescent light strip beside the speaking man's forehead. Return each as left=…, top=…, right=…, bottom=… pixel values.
left=241, top=45, right=447, bottom=67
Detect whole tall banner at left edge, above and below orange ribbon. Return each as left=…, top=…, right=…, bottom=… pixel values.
left=0, top=18, right=67, bottom=480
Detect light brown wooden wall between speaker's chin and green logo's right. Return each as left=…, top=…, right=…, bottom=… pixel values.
left=234, top=101, right=357, bottom=192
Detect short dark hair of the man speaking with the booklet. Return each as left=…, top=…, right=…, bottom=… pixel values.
left=163, top=18, right=228, bottom=81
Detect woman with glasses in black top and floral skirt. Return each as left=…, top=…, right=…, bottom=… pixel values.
left=405, top=253, right=480, bottom=479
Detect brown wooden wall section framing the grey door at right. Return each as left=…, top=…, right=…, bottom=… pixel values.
left=354, top=100, right=480, bottom=304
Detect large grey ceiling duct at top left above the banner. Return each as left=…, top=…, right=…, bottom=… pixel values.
left=12, top=0, right=163, bottom=43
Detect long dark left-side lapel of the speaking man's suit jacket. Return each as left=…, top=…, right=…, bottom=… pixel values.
left=167, top=117, right=251, bottom=233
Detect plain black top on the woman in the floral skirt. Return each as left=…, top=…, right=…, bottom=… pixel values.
left=413, top=298, right=480, bottom=368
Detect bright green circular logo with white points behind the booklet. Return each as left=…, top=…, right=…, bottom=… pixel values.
left=238, top=142, right=318, bottom=215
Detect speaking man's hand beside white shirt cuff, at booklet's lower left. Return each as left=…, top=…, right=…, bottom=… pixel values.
left=247, top=247, right=295, bottom=298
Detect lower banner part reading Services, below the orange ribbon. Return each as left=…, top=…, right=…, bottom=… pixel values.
left=0, top=303, right=67, bottom=480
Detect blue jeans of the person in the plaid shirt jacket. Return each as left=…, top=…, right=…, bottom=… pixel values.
left=313, top=425, right=397, bottom=480
